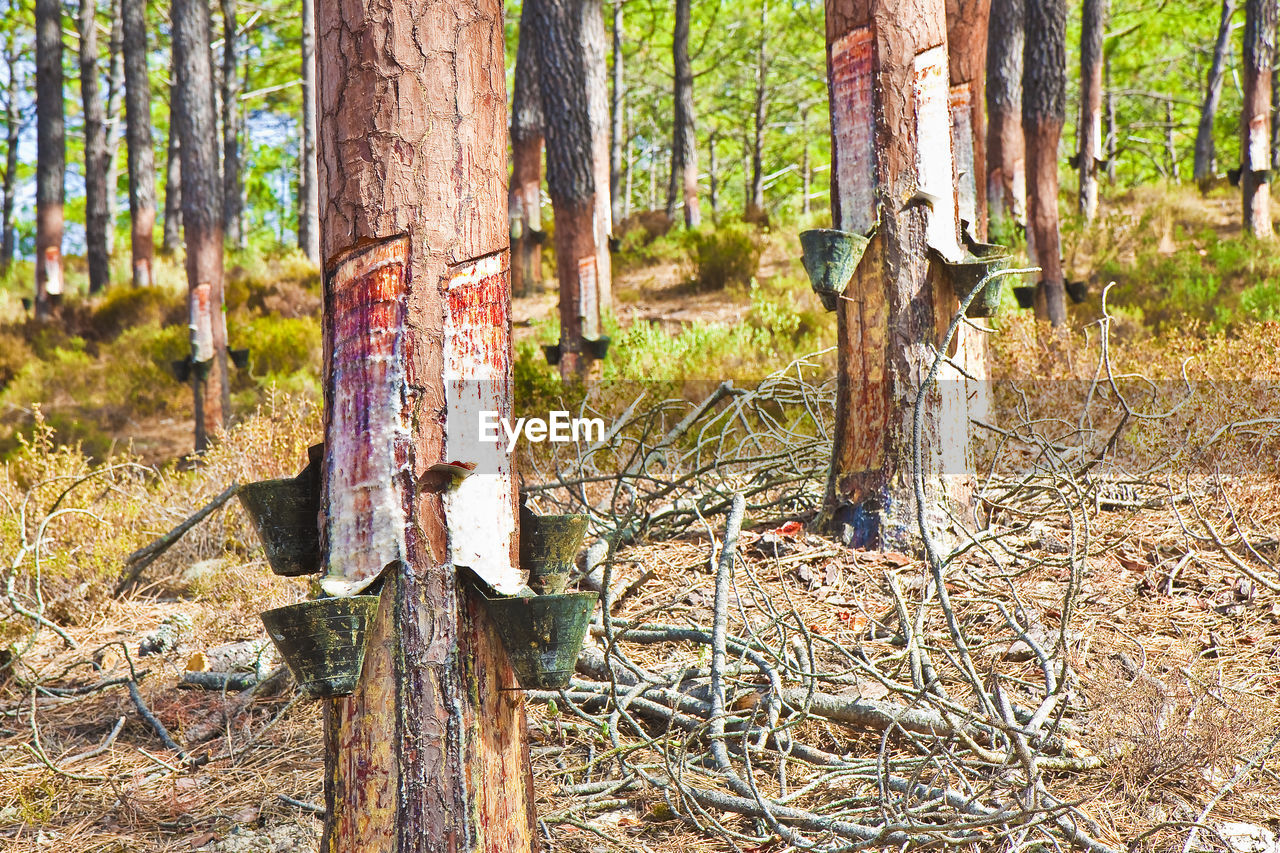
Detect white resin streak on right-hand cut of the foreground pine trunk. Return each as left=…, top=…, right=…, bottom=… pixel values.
left=444, top=255, right=524, bottom=596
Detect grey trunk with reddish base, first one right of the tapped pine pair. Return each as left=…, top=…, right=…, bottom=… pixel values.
left=987, top=0, right=1027, bottom=224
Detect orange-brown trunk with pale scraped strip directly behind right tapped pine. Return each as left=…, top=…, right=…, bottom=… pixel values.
left=946, top=0, right=991, bottom=236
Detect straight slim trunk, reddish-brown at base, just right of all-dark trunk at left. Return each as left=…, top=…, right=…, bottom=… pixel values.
left=120, top=0, right=156, bottom=287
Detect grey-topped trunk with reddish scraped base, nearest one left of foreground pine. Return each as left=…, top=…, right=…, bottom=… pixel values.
left=173, top=0, right=230, bottom=452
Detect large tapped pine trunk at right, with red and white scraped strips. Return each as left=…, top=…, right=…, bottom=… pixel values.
left=823, top=0, right=972, bottom=548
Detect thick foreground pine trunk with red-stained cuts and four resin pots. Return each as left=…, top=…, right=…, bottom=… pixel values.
left=316, top=0, right=537, bottom=853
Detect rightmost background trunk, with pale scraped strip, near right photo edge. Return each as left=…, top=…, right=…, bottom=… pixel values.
left=1240, top=0, right=1276, bottom=240
